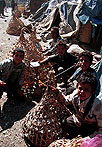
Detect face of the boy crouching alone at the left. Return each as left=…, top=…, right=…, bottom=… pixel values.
left=13, top=51, right=24, bottom=65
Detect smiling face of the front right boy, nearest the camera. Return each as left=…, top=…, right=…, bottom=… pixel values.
left=78, top=83, right=93, bottom=100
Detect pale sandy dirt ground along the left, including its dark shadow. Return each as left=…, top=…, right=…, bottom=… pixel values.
left=0, top=8, right=35, bottom=147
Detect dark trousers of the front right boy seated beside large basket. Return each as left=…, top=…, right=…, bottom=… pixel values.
left=62, top=116, right=97, bottom=139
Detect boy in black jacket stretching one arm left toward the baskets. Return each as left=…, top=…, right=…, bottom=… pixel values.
left=40, top=40, right=77, bottom=86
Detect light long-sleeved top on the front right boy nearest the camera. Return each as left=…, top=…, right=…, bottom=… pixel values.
left=59, top=89, right=102, bottom=135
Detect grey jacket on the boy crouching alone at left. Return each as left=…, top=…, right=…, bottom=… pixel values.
left=0, top=58, right=25, bottom=86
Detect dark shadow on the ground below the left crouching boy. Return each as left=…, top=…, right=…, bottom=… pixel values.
left=0, top=99, right=35, bottom=132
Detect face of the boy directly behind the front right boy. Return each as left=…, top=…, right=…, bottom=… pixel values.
left=79, top=56, right=91, bottom=71
